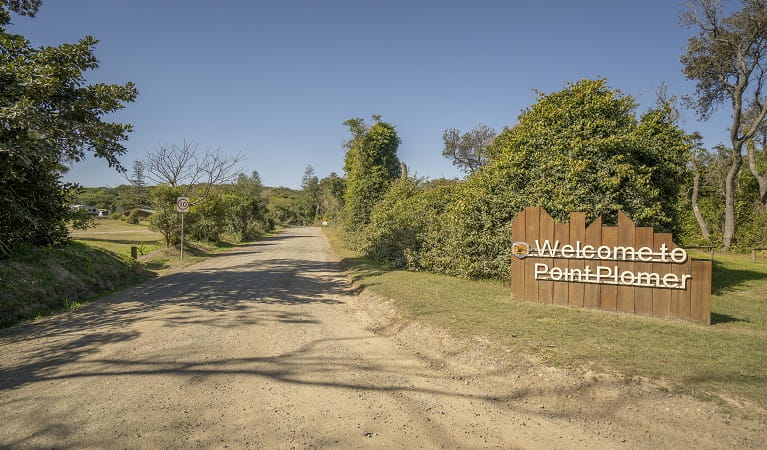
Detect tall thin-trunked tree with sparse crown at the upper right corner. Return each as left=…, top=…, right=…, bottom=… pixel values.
left=681, top=0, right=767, bottom=249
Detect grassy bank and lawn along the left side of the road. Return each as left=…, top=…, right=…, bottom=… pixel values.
left=0, top=219, right=258, bottom=327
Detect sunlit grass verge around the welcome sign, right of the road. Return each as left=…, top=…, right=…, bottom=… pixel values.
left=326, top=230, right=767, bottom=408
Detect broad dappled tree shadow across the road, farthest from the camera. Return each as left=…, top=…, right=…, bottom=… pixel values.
left=0, top=230, right=348, bottom=390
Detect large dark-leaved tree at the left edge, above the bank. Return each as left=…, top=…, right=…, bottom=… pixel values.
left=0, top=0, right=136, bottom=255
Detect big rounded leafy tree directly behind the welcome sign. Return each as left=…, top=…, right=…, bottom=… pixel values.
left=490, top=80, right=690, bottom=231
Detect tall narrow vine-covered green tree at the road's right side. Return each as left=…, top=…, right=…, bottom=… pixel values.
left=344, top=116, right=400, bottom=231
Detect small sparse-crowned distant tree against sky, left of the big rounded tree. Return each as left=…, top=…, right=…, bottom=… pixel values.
left=442, top=125, right=495, bottom=173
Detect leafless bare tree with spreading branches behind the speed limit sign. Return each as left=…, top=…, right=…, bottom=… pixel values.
left=144, top=141, right=245, bottom=204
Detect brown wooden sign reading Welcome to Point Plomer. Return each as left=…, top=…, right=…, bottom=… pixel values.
left=511, top=206, right=711, bottom=324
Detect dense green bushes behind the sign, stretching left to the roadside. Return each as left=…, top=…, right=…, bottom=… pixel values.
left=364, top=80, right=689, bottom=278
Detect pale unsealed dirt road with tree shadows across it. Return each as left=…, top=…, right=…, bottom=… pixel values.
left=0, top=228, right=760, bottom=448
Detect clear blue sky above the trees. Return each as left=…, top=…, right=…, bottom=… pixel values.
left=9, top=0, right=729, bottom=187
